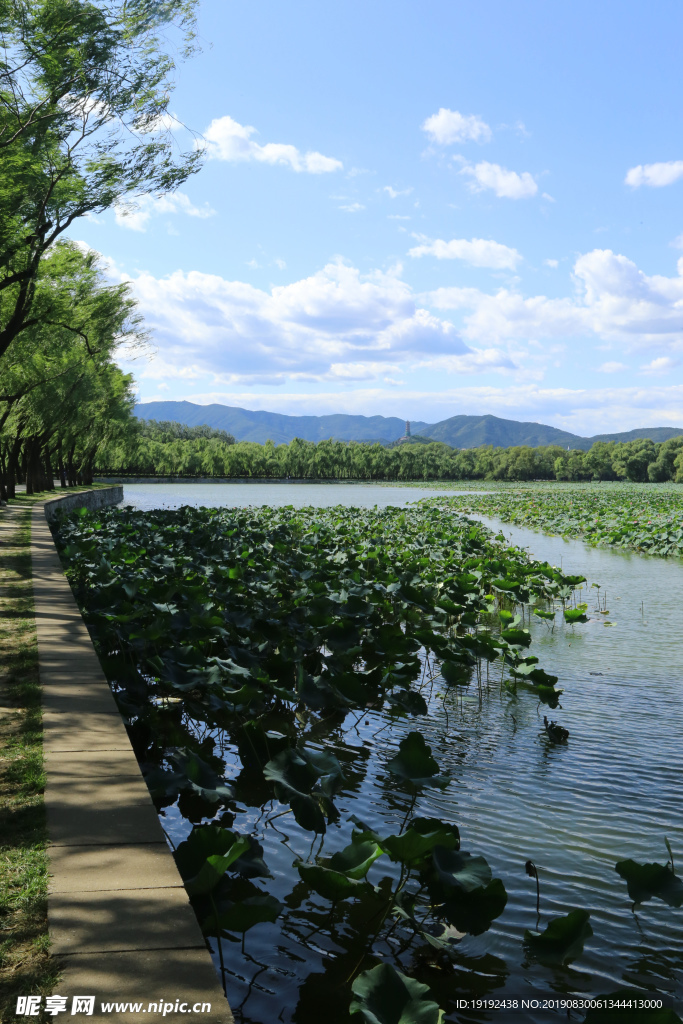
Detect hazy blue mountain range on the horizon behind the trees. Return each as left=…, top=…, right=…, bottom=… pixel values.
left=134, top=401, right=683, bottom=452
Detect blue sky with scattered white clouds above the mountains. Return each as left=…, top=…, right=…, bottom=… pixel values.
left=75, top=0, right=683, bottom=434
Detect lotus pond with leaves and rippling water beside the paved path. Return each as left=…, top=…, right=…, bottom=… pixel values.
left=50, top=493, right=683, bottom=1024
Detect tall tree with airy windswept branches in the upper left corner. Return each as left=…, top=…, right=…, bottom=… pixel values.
left=0, top=0, right=201, bottom=357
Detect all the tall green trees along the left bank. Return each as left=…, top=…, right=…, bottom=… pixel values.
left=0, top=0, right=201, bottom=499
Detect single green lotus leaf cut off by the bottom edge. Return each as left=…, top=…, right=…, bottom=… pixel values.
left=349, top=964, right=444, bottom=1024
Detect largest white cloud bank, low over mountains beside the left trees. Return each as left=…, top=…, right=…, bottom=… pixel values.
left=117, top=261, right=514, bottom=384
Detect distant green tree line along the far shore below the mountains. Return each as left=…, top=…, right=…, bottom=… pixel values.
left=94, top=420, right=683, bottom=482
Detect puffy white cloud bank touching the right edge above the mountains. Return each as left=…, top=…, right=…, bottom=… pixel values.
left=424, top=249, right=683, bottom=351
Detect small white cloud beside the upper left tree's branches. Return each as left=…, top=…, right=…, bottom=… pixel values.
left=198, top=116, right=343, bottom=174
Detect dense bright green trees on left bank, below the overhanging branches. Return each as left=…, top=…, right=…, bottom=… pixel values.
left=0, top=242, right=140, bottom=497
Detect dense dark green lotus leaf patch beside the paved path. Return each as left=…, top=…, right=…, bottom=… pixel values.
left=56, top=506, right=593, bottom=1007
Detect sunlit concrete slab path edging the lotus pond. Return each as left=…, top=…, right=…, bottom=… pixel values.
left=31, top=495, right=232, bottom=1024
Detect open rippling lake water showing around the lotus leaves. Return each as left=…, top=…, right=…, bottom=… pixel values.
left=114, top=484, right=683, bottom=1024
